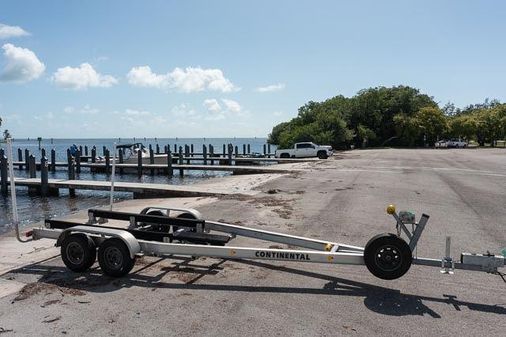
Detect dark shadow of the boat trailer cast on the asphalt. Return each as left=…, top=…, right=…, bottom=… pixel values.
left=8, top=259, right=506, bottom=318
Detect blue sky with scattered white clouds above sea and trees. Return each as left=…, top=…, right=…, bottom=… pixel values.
left=0, top=0, right=506, bottom=138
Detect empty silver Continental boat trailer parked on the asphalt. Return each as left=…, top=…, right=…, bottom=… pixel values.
left=3, top=140, right=506, bottom=282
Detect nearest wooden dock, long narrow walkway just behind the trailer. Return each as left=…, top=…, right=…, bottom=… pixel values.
left=9, top=178, right=239, bottom=199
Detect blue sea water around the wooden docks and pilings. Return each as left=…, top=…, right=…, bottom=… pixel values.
left=0, top=138, right=275, bottom=233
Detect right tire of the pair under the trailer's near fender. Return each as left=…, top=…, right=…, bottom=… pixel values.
left=98, top=238, right=135, bottom=277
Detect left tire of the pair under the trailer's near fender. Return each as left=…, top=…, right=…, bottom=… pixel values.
left=60, top=234, right=97, bottom=273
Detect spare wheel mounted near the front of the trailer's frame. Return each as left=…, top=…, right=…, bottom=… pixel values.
left=364, top=233, right=413, bottom=280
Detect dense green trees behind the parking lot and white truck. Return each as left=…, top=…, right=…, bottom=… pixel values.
left=268, top=86, right=506, bottom=149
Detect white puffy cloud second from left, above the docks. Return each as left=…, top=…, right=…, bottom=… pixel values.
left=52, top=63, right=118, bottom=90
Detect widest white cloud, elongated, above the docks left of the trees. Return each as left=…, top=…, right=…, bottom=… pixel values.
left=127, top=66, right=239, bottom=93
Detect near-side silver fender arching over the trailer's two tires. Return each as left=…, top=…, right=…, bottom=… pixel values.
left=56, top=226, right=141, bottom=259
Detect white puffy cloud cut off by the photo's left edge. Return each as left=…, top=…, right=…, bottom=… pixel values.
left=0, top=43, right=46, bottom=83
